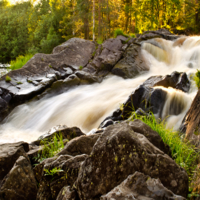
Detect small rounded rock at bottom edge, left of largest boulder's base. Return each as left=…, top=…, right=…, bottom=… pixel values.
left=56, top=186, right=79, bottom=200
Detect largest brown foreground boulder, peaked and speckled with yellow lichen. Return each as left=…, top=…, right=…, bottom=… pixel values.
left=77, top=123, right=188, bottom=200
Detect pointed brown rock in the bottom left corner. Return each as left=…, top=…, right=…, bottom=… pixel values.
left=0, top=156, right=37, bottom=200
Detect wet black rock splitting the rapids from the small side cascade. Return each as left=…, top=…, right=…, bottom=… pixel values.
left=100, top=72, right=190, bottom=123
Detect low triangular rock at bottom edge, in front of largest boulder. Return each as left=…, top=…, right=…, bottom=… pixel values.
left=100, top=172, right=186, bottom=200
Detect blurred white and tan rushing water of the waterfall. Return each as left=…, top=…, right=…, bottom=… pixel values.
left=0, top=37, right=200, bottom=143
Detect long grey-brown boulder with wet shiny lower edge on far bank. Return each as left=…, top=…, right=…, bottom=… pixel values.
left=0, top=38, right=95, bottom=121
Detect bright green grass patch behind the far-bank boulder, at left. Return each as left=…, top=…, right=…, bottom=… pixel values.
left=10, top=54, right=33, bottom=70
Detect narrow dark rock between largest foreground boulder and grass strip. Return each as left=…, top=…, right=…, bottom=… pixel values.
left=129, top=119, right=171, bottom=156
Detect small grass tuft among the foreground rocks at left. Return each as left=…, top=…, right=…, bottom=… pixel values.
left=35, top=134, right=64, bottom=162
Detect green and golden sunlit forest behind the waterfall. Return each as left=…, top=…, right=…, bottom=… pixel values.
left=0, top=0, right=200, bottom=63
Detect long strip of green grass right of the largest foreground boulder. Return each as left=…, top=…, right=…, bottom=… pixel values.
left=129, top=113, right=200, bottom=182
